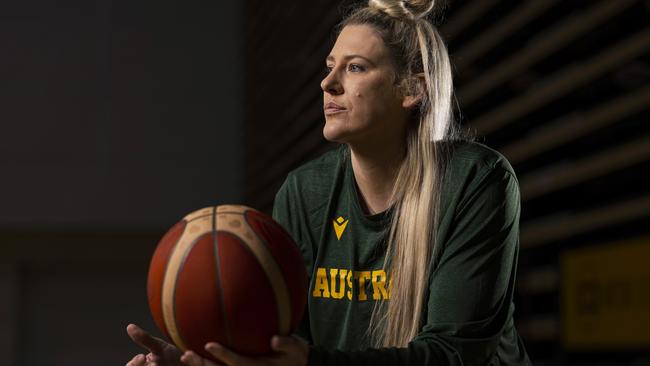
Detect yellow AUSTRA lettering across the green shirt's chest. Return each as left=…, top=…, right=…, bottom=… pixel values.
left=311, top=267, right=392, bottom=301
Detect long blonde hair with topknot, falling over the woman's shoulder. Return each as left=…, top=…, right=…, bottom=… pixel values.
left=339, top=0, right=460, bottom=347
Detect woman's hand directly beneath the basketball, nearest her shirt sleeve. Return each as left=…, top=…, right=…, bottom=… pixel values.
left=181, top=336, right=309, bottom=366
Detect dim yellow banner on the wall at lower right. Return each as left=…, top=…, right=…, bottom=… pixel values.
left=561, top=237, right=650, bottom=349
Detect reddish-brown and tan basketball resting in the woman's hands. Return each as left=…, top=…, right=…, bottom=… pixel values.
left=147, top=205, right=307, bottom=359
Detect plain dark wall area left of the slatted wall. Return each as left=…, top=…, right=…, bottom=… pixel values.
left=0, top=0, right=246, bottom=366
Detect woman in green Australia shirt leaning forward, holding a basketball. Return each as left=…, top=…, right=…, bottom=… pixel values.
left=128, top=0, right=530, bottom=366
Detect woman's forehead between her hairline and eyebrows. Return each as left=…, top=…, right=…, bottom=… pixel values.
left=328, top=25, right=388, bottom=62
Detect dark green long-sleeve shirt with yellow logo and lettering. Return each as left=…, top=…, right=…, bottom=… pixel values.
left=273, top=142, right=530, bottom=366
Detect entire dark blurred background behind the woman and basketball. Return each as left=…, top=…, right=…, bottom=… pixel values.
left=0, top=0, right=650, bottom=366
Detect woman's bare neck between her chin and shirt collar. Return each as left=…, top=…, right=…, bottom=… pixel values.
left=350, top=140, right=404, bottom=215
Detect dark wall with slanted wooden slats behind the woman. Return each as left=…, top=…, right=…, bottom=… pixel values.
left=245, top=0, right=650, bottom=364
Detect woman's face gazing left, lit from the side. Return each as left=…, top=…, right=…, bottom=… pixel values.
left=321, top=25, right=408, bottom=145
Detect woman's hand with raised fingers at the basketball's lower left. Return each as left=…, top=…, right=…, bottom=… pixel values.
left=126, top=324, right=182, bottom=366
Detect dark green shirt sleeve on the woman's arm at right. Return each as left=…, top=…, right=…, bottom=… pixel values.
left=309, top=165, right=528, bottom=366
